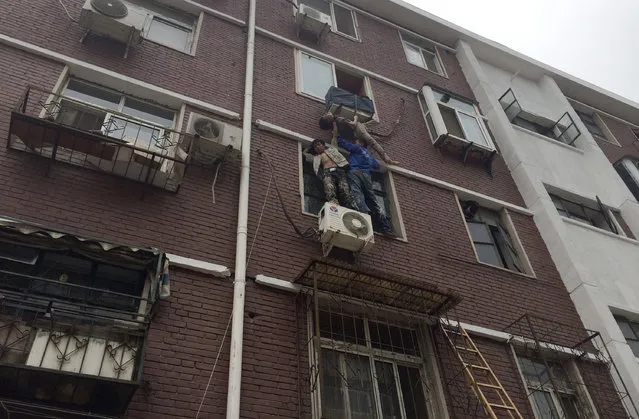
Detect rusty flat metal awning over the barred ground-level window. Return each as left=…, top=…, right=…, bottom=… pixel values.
left=295, top=259, right=461, bottom=316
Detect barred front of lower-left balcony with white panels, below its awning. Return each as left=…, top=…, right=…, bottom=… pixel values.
left=0, top=271, right=150, bottom=417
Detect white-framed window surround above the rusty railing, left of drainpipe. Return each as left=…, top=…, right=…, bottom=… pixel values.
left=58, top=77, right=179, bottom=155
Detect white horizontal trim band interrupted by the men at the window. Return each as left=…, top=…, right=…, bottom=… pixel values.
left=255, top=119, right=534, bottom=216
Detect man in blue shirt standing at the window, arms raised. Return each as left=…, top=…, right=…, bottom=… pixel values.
left=333, top=134, right=393, bottom=235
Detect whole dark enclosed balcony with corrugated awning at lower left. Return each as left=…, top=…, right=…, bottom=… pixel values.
left=0, top=218, right=163, bottom=418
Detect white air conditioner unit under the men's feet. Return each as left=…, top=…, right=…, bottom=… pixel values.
left=319, top=202, right=375, bottom=256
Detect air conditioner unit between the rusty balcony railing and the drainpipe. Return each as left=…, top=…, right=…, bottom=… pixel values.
left=187, top=113, right=242, bottom=163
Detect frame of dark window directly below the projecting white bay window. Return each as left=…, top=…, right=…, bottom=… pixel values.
left=454, top=199, right=536, bottom=278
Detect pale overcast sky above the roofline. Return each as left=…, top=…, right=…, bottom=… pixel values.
left=405, top=0, right=639, bottom=102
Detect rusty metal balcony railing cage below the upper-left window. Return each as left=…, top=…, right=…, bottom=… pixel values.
left=8, top=86, right=191, bottom=192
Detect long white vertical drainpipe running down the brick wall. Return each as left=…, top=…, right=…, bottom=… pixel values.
left=226, top=0, right=255, bottom=419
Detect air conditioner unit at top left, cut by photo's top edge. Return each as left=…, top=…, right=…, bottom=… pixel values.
left=80, top=0, right=147, bottom=45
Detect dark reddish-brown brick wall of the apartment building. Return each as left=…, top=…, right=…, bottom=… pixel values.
left=0, top=0, right=632, bottom=418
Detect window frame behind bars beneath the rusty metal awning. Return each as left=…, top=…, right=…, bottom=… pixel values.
left=307, top=306, right=449, bottom=419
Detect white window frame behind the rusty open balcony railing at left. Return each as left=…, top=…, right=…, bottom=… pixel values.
left=54, top=76, right=179, bottom=153
